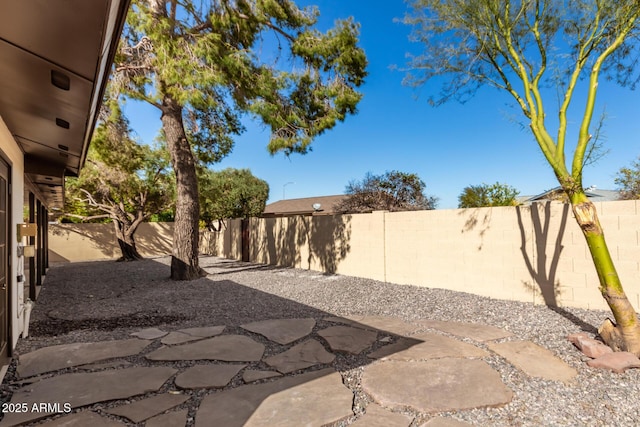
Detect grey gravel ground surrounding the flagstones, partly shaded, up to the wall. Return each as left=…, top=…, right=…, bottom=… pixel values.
left=0, top=257, right=640, bottom=426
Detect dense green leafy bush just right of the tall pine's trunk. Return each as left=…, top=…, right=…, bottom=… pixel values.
left=198, top=168, right=269, bottom=227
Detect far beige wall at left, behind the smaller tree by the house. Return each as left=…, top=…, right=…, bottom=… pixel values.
left=49, top=222, right=173, bottom=263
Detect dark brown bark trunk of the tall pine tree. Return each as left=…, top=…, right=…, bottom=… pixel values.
left=161, top=95, right=206, bottom=280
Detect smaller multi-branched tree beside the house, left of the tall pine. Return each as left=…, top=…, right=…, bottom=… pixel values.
left=65, top=104, right=174, bottom=261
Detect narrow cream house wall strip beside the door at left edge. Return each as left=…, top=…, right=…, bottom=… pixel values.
left=0, top=117, right=24, bottom=348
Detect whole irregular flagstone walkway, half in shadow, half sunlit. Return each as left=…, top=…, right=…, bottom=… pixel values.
left=0, top=316, right=576, bottom=427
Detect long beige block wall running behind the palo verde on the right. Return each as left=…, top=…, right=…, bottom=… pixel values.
left=201, top=201, right=640, bottom=310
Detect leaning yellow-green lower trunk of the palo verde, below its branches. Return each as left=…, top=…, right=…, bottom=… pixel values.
left=570, top=191, right=640, bottom=356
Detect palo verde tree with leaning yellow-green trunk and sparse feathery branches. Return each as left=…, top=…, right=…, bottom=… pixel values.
left=405, top=0, right=640, bottom=355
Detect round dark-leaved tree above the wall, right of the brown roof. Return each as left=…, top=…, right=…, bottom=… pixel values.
left=337, top=171, right=437, bottom=212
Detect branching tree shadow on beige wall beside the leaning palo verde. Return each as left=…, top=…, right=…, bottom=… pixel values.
left=516, top=202, right=597, bottom=333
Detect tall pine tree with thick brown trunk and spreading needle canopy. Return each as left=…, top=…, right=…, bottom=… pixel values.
left=114, top=0, right=366, bottom=280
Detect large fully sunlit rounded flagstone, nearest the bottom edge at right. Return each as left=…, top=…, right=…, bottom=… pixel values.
left=362, top=358, right=513, bottom=412
